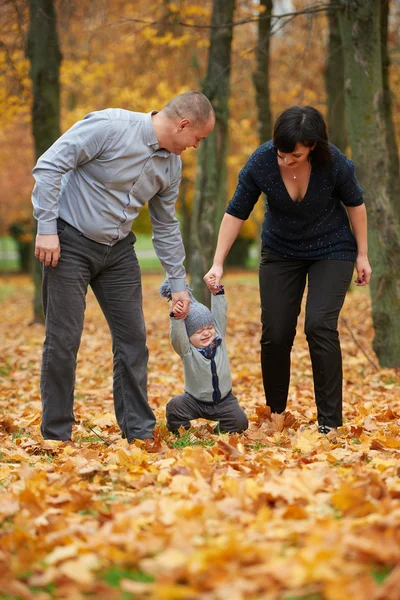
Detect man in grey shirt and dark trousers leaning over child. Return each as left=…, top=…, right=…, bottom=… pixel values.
left=32, top=91, right=215, bottom=442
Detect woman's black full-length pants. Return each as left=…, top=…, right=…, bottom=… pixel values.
left=259, top=253, right=354, bottom=427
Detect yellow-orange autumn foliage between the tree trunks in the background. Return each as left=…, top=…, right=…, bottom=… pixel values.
left=0, top=0, right=400, bottom=237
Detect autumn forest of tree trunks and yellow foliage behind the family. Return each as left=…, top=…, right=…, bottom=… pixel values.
left=0, top=0, right=400, bottom=367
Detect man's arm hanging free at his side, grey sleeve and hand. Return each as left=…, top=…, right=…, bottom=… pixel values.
left=32, top=113, right=110, bottom=267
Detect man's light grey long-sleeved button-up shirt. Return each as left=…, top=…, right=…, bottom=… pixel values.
left=32, top=108, right=186, bottom=292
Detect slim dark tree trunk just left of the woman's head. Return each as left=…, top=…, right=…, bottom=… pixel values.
left=253, top=0, right=273, bottom=144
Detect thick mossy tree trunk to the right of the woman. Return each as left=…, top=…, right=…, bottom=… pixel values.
left=340, top=0, right=400, bottom=367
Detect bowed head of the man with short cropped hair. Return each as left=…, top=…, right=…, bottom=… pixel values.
left=153, top=91, right=215, bottom=155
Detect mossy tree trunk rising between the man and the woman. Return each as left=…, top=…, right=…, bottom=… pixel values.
left=190, top=0, right=235, bottom=304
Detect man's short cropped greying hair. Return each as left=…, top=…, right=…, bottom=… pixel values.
left=163, top=91, right=214, bottom=127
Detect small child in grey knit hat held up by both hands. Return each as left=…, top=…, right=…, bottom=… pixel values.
left=160, top=281, right=248, bottom=433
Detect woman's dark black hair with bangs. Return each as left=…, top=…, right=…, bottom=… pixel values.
left=273, top=106, right=332, bottom=164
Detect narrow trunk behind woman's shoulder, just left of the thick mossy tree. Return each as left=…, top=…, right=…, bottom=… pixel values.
left=325, top=0, right=347, bottom=152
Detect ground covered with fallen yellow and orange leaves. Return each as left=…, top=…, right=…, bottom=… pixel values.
left=0, top=272, right=400, bottom=600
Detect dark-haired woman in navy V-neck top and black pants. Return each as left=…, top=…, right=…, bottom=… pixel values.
left=204, top=106, right=371, bottom=434
